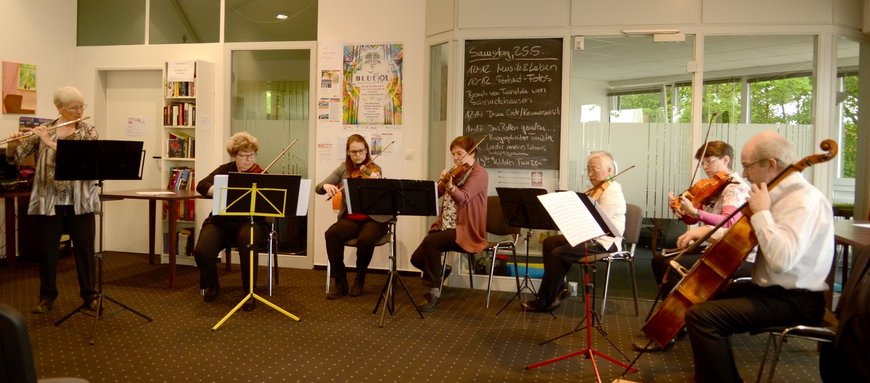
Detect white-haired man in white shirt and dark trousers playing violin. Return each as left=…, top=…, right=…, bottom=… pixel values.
left=522, top=151, right=626, bottom=312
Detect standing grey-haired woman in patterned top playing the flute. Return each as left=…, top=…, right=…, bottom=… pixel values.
left=6, top=87, right=99, bottom=314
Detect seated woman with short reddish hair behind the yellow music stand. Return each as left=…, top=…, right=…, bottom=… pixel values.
left=193, top=132, right=268, bottom=311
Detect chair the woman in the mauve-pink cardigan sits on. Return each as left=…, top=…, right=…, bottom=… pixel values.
left=440, top=196, right=520, bottom=308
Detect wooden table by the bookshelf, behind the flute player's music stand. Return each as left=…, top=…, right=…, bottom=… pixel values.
left=103, top=188, right=202, bottom=288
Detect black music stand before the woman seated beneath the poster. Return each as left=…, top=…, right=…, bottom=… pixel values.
left=344, top=178, right=438, bottom=327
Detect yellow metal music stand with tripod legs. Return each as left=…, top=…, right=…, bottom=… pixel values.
left=211, top=182, right=300, bottom=331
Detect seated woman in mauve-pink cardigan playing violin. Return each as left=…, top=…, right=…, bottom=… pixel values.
left=411, top=136, right=489, bottom=312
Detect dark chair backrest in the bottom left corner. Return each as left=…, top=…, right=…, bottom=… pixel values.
left=0, top=304, right=36, bottom=383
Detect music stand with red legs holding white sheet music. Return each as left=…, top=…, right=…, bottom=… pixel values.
left=526, top=192, right=637, bottom=382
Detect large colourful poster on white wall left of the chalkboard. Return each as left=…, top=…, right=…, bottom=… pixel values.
left=341, top=44, right=403, bottom=125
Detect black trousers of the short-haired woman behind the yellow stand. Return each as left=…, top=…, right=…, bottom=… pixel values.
left=193, top=217, right=268, bottom=294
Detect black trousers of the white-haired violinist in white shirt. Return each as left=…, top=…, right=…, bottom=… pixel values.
left=538, top=235, right=608, bottom=307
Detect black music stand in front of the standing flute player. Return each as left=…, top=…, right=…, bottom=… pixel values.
left=54, top=140, right=152, bottom=345
